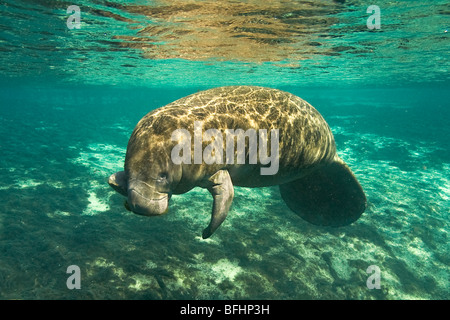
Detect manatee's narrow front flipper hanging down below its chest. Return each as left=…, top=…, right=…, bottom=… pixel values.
left=202, top=170, right=234, bottom=239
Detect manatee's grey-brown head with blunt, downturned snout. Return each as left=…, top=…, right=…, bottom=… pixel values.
left=108, top=139, right=181, bottom=216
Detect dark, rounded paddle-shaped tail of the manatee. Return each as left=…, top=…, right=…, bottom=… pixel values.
left=280, top=156, right=367, bottom=227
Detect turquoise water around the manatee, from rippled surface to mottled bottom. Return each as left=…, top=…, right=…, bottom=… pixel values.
left=0, top=0, right=450, bottom=299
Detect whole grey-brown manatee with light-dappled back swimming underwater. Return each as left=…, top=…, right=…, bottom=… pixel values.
left=108, top=86, right=367, bottom=239
